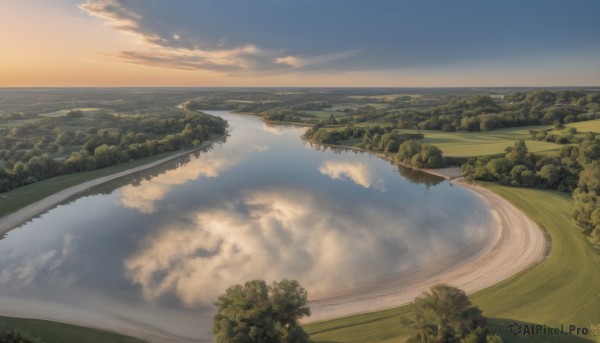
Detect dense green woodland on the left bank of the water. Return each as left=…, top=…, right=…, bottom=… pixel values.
left=0, top=112, right=227, bottom=192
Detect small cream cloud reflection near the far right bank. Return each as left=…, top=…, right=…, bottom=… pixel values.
left=319, top=161, right=385, bottom=192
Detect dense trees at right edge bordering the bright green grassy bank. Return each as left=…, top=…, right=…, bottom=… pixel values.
left=462, top=133, right=600, bottom=244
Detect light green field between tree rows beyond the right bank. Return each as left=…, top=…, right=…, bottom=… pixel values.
left=399, top=126, right=561, bottom=157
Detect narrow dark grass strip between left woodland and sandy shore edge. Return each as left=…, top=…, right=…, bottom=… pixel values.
left=0, top=152, right=177, bottom=217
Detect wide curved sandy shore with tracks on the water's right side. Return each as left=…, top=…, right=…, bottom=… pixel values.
left=306, top=180, right=547, bottom=322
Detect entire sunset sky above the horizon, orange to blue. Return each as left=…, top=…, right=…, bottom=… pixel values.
left=0, top=0, right=600, bottom=87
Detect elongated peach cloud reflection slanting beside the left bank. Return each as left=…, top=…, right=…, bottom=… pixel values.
left=119, top=144, right=267, bottom=214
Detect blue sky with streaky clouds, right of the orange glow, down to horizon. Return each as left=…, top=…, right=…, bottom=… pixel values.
left=0, top=0, right=600, bottom=86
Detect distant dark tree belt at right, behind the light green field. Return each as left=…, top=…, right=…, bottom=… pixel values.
left=382, top=90, right=600, bottom=132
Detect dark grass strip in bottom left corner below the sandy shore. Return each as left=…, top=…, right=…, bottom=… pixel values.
left=0, top=317, right=145, bottom=343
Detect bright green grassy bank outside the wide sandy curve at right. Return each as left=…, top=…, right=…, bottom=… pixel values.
left=306, top=184, right=600, bottom=343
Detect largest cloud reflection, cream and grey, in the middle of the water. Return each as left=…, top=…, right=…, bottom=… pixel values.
left=124, top=189, right=485, bottom=307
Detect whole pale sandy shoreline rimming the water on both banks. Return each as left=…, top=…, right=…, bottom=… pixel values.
left=0, top=117, right=547, bottom=342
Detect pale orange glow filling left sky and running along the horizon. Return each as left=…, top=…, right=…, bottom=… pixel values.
left=0, top=1, right=600, bottom=87
